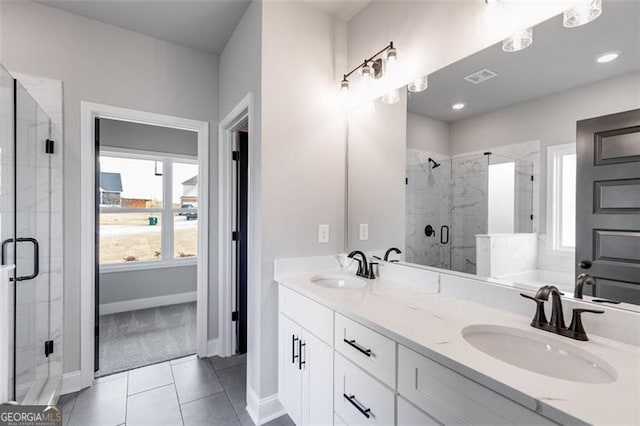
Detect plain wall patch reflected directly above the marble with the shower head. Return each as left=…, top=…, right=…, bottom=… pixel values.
left=403, top=112, right=451, bottom=156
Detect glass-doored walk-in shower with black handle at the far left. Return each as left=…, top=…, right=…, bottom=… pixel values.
left=0, top=68, right=62, bottom=404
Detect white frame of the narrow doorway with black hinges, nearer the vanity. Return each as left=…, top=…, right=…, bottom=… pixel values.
left=218, top=93, right=255, bottom=360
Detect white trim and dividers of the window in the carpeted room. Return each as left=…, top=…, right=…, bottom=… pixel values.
left=100, top=147, right=198, bottom=274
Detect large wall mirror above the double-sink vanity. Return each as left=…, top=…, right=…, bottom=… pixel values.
left=347, top=2, right=640, bottom=306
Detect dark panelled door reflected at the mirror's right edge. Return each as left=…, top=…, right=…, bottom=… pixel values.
left=576, top=109, right=640, bottom=304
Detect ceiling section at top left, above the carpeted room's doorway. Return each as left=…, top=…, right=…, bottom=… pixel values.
left=38, top=0, right=251, bottom=55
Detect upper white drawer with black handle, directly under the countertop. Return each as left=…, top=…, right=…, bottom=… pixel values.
left=334, top=313, right=396, bottom=389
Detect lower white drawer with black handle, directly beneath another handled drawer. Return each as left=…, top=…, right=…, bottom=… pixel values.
left=334, top=353, right=395, bottom=425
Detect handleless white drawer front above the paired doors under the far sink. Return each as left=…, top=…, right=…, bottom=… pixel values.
left=278, top=285, right=333, bottom=346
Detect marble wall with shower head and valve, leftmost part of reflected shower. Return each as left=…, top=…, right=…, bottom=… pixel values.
left=405, top=149, right=451, bottom=269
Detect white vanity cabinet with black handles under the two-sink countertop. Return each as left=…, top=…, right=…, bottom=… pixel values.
left=279, top=285, right=555, bottom=425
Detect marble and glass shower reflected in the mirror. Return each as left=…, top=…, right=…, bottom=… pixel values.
left=406, top=149, right=533, bottom=274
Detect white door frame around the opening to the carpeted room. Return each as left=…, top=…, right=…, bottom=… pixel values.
left=80, top=101, right=209, bottom=387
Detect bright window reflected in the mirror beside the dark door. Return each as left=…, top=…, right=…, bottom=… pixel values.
left=547, top=144, right=576, bottom=252
